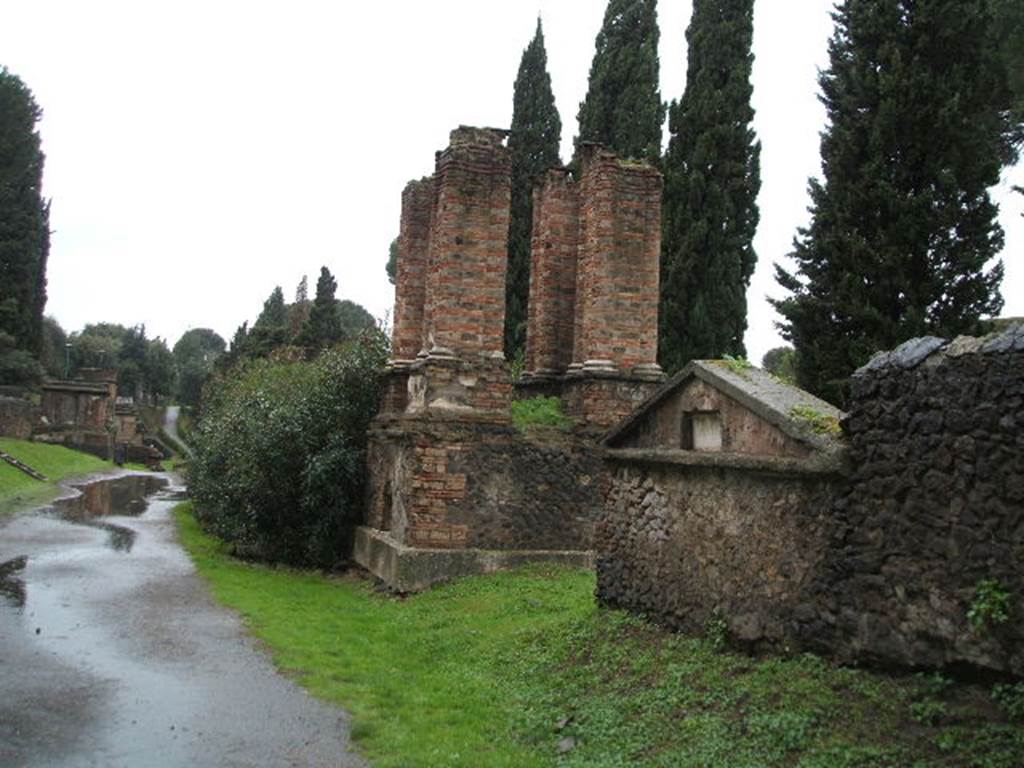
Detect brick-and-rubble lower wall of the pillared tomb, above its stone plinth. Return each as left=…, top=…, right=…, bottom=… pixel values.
left=367, top=417, right=604, bottom=550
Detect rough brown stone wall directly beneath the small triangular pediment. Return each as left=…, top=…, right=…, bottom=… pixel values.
left=595, top=451, right=833, bottom=647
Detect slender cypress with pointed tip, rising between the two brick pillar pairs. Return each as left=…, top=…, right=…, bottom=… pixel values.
left=505, top=18, right=562, bottom=359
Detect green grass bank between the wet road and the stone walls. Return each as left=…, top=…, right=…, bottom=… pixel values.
left=176, top=503, right=1024, bottom=768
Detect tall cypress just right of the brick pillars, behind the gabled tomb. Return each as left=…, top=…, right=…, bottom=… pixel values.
left=658, top=0, right=761, bottom=372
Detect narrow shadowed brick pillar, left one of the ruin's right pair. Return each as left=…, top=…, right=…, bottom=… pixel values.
left=526, top=169, right=580, bottom=376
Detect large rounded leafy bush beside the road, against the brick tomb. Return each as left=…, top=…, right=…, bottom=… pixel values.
left=188, top=329, right=387, bottom=567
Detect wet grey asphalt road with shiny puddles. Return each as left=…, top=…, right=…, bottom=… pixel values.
left=0, top=478, right=365, bottom=768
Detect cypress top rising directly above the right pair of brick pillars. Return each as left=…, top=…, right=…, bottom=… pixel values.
left=578, top=0, right=665, bottom=162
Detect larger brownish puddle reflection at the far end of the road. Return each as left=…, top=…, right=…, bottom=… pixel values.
left=53, top=475, right=168, bottom=552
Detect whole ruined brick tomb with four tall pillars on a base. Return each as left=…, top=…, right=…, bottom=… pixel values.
left=354, top=127, right=664, bottom=591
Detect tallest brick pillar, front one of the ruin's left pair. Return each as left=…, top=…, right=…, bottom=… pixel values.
left=425, top=127, right=511, bottom=359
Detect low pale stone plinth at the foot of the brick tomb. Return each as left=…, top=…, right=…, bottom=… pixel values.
left=352, top=525, right=594, bottom=592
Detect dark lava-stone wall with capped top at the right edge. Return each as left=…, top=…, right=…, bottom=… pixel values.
left=804, top=326, right=1024, bottom=675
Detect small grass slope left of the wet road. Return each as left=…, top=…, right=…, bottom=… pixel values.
left=0, top=437, right=113, bottom=513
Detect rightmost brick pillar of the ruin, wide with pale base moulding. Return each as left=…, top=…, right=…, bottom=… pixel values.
left=573, top=144, right=662, bottom=375
